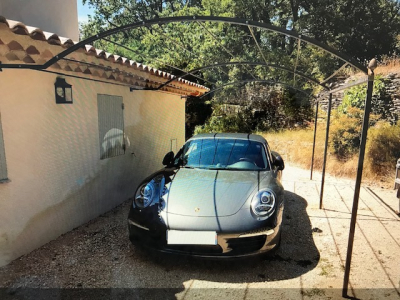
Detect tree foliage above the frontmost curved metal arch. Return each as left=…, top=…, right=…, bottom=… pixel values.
left=82, top=0, right=400, bottom=59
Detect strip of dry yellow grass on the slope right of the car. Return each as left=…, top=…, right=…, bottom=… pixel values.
left=260, top=121, right=394, bottom=187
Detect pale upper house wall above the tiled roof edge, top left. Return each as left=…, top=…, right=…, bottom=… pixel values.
left=0, top=0, right=79, bottom=41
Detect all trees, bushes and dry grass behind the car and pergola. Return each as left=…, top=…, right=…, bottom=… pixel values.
left=80, top=0, right=400, bottom=182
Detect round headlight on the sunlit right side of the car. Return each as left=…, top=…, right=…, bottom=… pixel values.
left=251, top=189, right=276, bottom=221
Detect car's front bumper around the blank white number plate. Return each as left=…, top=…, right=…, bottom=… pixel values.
left=128, top=219, right=281, bottom=258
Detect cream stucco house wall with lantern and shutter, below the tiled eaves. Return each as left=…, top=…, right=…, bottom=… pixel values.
left=0, top=70, right=185, bottom=266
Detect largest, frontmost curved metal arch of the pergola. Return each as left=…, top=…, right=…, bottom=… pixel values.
left=0, top=16, right=368, bottom=74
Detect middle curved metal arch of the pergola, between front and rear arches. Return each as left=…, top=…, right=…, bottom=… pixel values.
left=156, top=61, right=329, bottom=90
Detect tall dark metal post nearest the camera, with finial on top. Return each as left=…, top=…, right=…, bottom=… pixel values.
left=342, top=68, right=374, bottom=297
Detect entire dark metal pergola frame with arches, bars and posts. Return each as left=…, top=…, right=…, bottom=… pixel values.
left=0, top=16, right=376, bottom=297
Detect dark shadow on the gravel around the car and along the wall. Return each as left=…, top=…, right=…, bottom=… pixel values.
left=0, top=191, right=320, bottom=299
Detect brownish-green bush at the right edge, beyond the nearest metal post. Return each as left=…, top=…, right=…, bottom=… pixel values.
left=366, top=122, right=400, bottom=173
